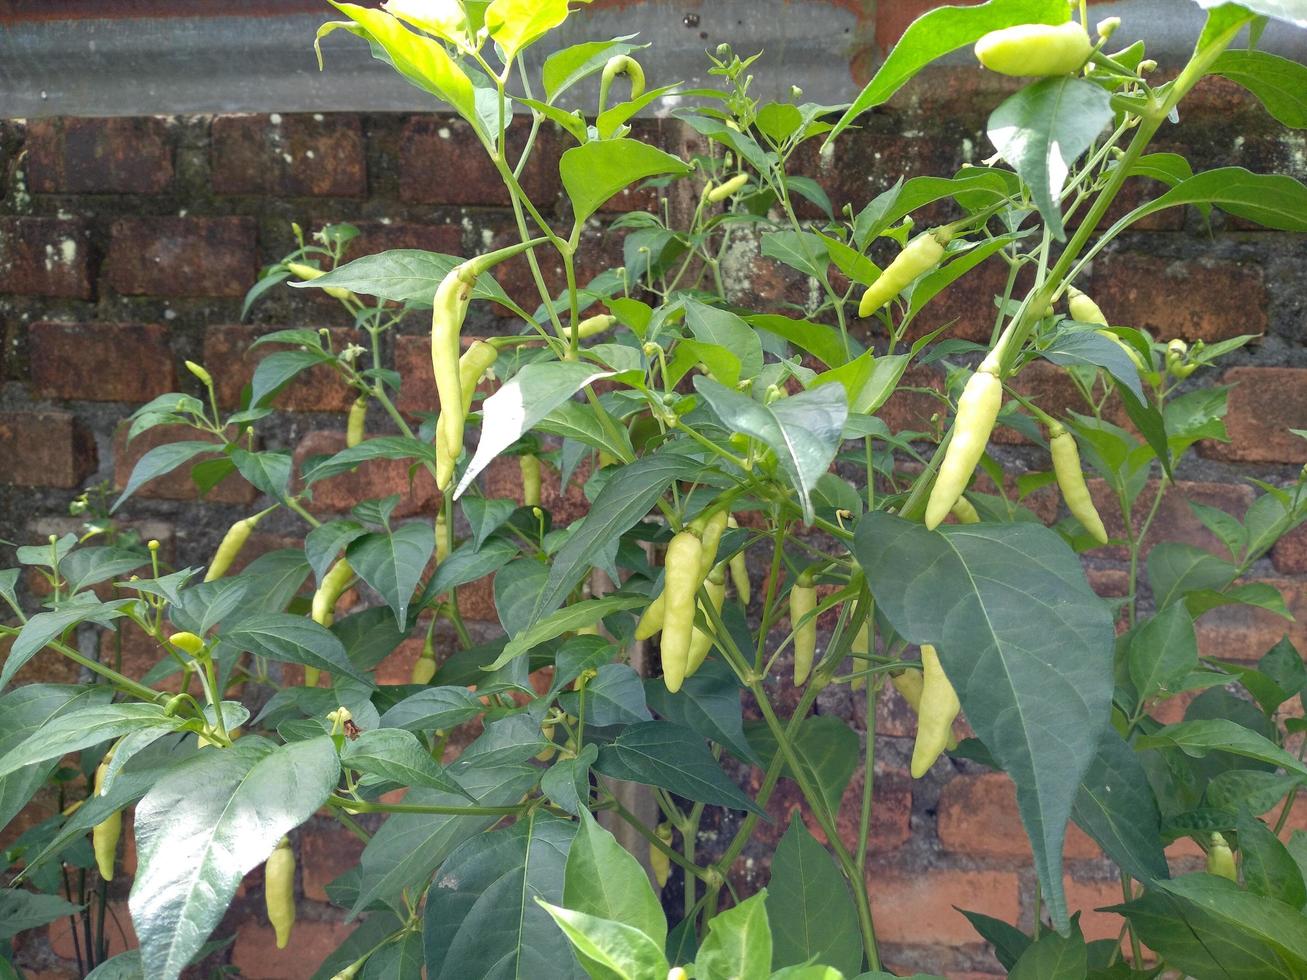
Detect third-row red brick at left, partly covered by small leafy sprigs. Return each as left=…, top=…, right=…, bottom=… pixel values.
left=204, top=325, right=358, bottom=412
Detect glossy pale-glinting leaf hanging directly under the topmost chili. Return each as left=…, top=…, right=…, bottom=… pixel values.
left=987, top=74, right=1112, bottom=242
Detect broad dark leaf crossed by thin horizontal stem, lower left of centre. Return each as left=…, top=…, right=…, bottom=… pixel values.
left=350, top=763, right=540, bottom=915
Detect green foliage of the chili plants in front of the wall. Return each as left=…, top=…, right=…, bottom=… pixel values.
left=0, top=0, right=1307, bottom=980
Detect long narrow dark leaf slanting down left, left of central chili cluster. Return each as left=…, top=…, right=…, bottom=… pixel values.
left=528, top=453, right=703, bottom=623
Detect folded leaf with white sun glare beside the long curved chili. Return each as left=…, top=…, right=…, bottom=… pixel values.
left=454, top=363, right=612, bottom=498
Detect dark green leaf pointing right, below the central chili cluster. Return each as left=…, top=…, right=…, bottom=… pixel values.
left=595, top=721, right=762, bottom=815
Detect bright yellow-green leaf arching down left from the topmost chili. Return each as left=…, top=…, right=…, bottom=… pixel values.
left=826, top=0, right=1067, bottom=142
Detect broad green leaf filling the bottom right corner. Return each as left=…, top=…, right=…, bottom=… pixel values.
left=1108, top=874, right=1307, bottom=980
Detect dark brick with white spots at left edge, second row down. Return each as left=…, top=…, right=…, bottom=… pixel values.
left=0, top=218, right=93, bottom=299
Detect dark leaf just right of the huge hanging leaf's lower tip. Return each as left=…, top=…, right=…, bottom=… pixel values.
left=1070, top=728, right=1171, bottom=882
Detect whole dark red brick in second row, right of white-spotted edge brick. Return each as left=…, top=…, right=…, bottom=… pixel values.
left=107, top=217, right=256, bottom=297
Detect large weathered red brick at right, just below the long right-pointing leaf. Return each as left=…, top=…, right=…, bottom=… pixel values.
left=1090, top=252, right=1266, bottom=341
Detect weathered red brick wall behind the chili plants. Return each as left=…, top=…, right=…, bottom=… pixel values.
left=0, top=55, right=1307, bottom=977
